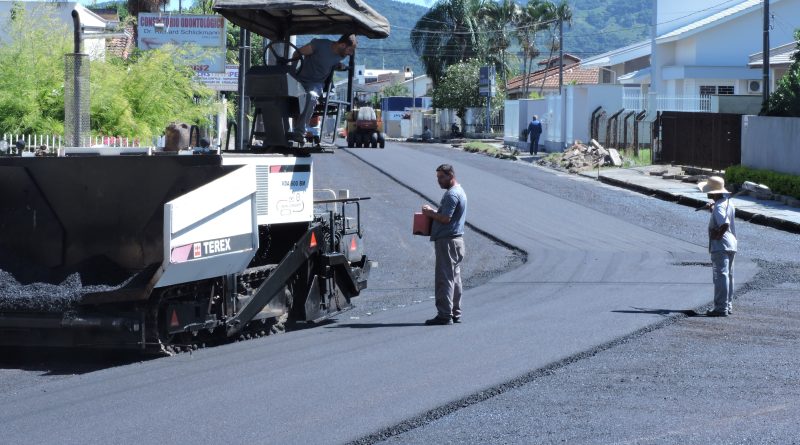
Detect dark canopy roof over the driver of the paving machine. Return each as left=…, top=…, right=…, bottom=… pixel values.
left=214, top=0, right=389, bottom=40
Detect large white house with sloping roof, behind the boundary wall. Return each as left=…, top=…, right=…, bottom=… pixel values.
left=582, top=0, right=800, bottom=97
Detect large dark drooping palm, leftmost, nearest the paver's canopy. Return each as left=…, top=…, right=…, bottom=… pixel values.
left=411, top=0, right=485, bottom=86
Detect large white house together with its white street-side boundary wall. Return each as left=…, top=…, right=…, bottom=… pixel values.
left=504, top=0, right=800, bottom=150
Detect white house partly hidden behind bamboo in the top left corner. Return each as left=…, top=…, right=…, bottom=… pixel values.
left=0, top=1, right=109, bottom=60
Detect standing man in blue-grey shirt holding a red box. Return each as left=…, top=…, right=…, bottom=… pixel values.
left=422, top=164, right=467, bottom=325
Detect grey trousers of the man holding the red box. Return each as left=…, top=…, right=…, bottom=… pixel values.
left=433, top=237, right=464, bottom=318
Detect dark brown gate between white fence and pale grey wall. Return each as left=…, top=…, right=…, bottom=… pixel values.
left=658, top=111, right=742, bottom=170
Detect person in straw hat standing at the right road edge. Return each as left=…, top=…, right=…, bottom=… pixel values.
left=698, top=176, right=737, bottom=317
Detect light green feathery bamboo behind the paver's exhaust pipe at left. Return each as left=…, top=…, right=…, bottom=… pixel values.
left=0, top=6, right=212, bottom=140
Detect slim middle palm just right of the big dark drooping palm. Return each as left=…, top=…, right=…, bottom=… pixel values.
left=478, top=0, right=522, bottom=81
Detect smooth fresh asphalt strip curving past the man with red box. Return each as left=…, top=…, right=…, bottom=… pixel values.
left=0, top=141, right=755, bottom=443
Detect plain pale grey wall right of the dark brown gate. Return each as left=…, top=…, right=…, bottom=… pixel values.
left=742, top=116, right=800, bottom=175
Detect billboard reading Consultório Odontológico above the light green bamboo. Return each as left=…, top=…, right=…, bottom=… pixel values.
left=136, top=13, right=225, bottom=73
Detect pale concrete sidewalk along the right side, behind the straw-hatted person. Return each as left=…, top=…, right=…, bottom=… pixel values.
left=580, top=165, right=800, bottom=233
